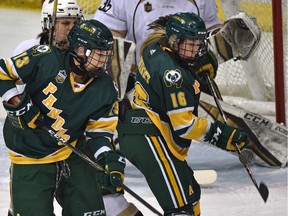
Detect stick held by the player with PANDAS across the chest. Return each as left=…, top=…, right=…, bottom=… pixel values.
left=36, top=120, right=162, bottom=215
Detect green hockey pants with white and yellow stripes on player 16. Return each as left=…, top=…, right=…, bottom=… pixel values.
left=117, top=110, right=201, bottom=216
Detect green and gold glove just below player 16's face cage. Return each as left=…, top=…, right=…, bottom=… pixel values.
left=195, top=51, right=218, bottom=83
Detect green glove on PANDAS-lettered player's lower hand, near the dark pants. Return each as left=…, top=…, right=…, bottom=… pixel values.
left=97, top=151, right=126, bottom=193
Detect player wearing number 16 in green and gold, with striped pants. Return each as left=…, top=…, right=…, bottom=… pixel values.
left=117, top=13, right=247, bottom=216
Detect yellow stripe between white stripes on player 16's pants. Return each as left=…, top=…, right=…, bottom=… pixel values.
left=150, top=136, right=184, bottom=207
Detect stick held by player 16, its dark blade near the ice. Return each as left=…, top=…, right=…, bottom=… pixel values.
left=206, top=74, right=269, bottom=203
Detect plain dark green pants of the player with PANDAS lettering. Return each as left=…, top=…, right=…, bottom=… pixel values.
left=11, top=153, right=106, bottom=216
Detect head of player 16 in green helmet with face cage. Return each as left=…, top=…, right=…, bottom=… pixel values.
left=166, top=13, right=207, bottom=69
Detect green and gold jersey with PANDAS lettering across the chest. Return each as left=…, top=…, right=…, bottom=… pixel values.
left=0, top=45, right=118, bottom=164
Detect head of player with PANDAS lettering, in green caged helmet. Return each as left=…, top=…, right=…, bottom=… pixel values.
left=68, top=20, right=114, bottom=77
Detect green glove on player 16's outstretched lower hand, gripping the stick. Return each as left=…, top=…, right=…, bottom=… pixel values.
left=204, top=121, right=249, bottom=151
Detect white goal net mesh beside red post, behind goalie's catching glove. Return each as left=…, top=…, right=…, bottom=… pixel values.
left=216, top=0, right=288, bottom=101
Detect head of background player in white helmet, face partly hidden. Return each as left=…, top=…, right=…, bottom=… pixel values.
left=41, top=0, right=83, bottom=49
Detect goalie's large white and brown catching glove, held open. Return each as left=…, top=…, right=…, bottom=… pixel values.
left=207, top=12, right=261, bottom=64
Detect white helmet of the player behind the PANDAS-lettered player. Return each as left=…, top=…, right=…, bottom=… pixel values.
left=41, top=0, right=83, bottom=30
